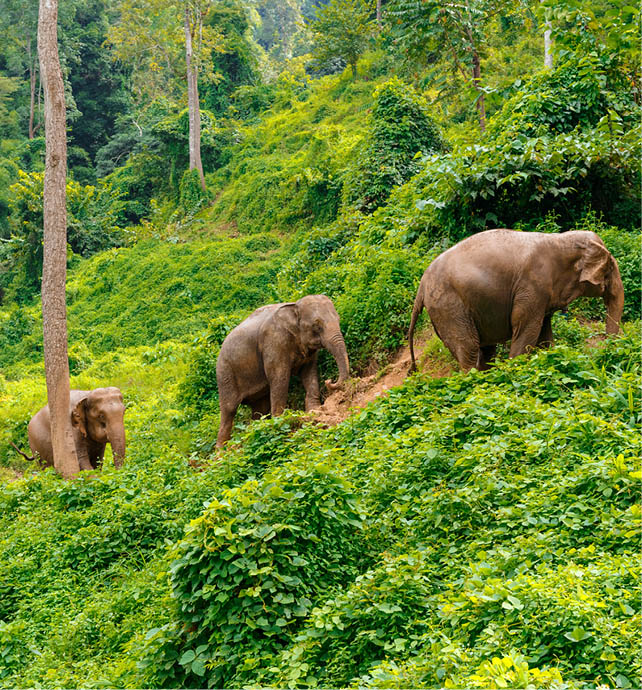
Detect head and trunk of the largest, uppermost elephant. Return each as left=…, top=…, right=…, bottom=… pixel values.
left=576, top=233, right=624, bottom=334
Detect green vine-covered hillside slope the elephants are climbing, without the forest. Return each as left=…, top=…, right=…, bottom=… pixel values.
left=0, top=45, right=642, bottom=688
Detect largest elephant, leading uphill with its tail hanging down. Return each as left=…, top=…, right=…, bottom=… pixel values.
left=408, top=229, right=624, bottom=371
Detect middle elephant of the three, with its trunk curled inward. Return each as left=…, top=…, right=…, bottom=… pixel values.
left=216, top=295, right=350, bottom=448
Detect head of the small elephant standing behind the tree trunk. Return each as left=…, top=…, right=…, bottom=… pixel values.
left=71, top=387, right=125, bottom=467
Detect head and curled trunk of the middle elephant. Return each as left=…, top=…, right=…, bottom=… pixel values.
left=284, top=295, right=350, bottom=390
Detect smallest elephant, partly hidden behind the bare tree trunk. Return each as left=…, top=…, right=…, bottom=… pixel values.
left=28, top=387, right=125, bottom=470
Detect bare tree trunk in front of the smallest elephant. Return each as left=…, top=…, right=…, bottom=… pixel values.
left=38, top=0, right=80, bottom=479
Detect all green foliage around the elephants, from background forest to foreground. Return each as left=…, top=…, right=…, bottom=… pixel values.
left=0, top=0, right=642, bottom=689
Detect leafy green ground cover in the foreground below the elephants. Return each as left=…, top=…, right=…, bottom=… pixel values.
left=0, top=323, right=642, bottom=687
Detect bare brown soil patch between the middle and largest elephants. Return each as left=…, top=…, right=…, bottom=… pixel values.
left=313, top=328, right=456, bottom=426
